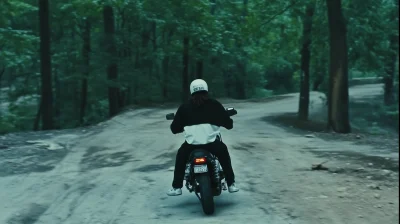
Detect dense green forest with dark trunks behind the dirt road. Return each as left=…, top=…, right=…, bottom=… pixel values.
left=0, top=0, right=399, bottom=134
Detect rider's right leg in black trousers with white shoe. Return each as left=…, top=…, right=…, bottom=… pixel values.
left=208, top=140, right=239, bottom=192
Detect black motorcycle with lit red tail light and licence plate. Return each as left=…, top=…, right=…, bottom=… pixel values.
left=166, top=108, right=237, bottom=215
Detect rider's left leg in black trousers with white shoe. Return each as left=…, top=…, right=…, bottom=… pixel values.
left=167, top=141, right=192, bottom=196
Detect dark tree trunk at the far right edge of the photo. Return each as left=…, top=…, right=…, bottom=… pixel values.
left=383, top=0, right=399, bottom=105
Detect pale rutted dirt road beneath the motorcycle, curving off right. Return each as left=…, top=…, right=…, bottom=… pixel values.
left=0, top=84, right=399, bottom=224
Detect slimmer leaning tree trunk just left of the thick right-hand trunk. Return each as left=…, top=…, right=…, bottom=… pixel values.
left=298, top=1, right=315, bottom=121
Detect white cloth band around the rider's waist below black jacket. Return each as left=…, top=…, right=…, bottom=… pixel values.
left=184, top=124, right=221, bottom=145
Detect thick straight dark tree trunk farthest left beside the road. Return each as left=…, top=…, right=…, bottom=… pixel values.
left=39, top=0, right=53, bottom=130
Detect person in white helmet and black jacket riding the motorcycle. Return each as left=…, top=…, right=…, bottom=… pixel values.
left=167, top=79, right=239, bottom=196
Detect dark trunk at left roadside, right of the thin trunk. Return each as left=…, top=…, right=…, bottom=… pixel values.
left=103, top=5, right=120, bottom=117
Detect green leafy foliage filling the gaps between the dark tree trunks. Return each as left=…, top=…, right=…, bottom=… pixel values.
left=0, top=0, right=398, bottom=133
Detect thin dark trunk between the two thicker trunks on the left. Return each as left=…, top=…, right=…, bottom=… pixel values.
left=79, top=19, right=91, bottom=125
